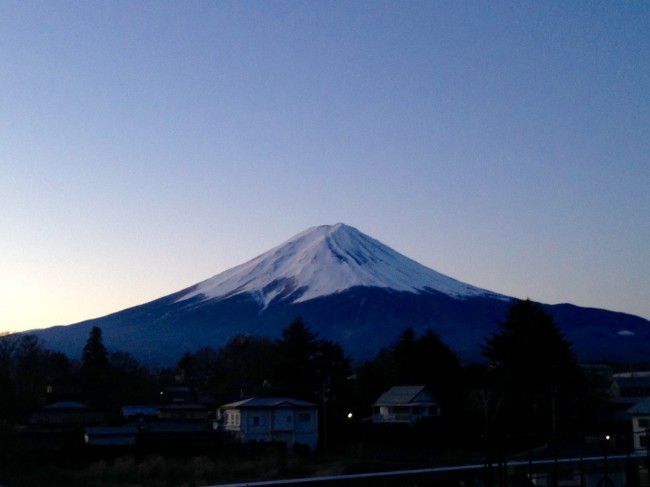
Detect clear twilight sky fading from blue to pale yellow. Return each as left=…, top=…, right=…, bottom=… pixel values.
left=0, top=0, right=650, bottom=330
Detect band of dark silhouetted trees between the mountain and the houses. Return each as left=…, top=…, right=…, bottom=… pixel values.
left=0, top=301, right=599, bottom=442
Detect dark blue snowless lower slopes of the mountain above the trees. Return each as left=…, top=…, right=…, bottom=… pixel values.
left=31, top=287, right=650, bottom=364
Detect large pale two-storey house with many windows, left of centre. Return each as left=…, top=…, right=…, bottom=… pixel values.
left=218, top=397, right=318, bottom=449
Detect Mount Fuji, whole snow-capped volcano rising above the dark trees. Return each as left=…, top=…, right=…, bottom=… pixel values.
left=30, top=223, right=650, bottom=365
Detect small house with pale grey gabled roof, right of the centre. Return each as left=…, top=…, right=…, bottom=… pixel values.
left=372, top=386, right=440, bottom=424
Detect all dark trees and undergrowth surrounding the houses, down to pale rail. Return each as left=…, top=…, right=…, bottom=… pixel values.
left=0, top=301, right=629, bottom=485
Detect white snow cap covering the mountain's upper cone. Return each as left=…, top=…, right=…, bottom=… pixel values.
left=178, top=223, right=502, bottom=307
